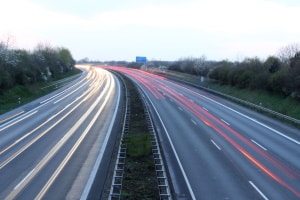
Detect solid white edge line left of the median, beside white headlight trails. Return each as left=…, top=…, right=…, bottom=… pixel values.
left=80, top=72, right=121, bottom=200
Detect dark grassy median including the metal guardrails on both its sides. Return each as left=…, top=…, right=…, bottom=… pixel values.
left=109, top=72, right=170, bottom=199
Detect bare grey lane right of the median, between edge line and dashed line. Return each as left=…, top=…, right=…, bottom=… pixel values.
left=149, top=93, right=257, bottom=199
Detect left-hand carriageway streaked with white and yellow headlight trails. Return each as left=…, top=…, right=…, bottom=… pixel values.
left=0, top=66, right=122, bottom=200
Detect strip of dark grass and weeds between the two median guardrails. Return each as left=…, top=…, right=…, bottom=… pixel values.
left=121, top=74, right=159, bottom=199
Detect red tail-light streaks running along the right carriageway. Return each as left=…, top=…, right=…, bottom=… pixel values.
left=109, top=68, right=300, bottom=198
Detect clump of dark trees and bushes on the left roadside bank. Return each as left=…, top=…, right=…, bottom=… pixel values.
left=0, top=42, right=75, bottom=94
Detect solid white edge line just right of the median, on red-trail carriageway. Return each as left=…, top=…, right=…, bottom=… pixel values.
left=140, top=87, right=196, bottom=200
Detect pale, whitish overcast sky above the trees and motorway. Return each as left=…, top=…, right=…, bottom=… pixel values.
left=0, top=0, right=300, bottom=61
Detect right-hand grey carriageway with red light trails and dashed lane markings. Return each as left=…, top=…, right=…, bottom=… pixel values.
left=110, top=67, right=300, bottom=200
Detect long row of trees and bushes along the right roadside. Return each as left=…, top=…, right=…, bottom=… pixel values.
left=169, top=44, right=300, bottom=100
